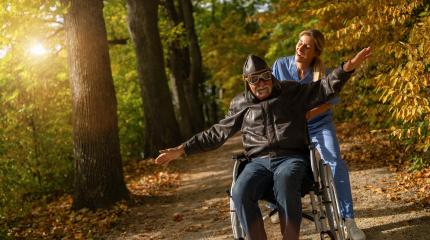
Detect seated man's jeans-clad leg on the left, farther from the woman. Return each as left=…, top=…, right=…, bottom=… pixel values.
left=231, top=158, right=272, bottom=240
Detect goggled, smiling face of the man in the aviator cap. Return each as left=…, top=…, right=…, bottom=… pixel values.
left=245, top=70, right=273, bottom=100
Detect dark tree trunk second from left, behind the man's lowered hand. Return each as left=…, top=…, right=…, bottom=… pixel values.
left=127, top=0, right=180, bottom=156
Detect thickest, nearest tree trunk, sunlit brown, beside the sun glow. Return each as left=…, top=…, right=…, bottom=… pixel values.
left=63, top=0, right=128, bottom=209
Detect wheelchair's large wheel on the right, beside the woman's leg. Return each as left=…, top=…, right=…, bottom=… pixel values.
left=322, top=164, right=346, bottom=240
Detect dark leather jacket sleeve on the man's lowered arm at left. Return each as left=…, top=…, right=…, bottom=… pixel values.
left=183, top=94, right=246, bottom=155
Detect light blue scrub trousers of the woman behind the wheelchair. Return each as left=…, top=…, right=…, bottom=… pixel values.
left=310, top=121, right=354, bottom=218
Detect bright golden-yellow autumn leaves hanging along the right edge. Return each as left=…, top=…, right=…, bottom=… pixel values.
left=310, top=1, right=430, bottom=156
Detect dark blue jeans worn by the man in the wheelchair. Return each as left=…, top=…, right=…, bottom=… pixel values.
left=232, top=155, right=309, bottom=240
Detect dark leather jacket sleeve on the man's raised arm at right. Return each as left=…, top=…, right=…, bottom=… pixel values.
left=289, top=63, right=353, bottom=111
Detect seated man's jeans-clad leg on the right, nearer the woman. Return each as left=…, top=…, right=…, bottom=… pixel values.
left=272, top=156, right=307, bottom=240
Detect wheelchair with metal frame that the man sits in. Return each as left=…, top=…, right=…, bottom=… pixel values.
left=227, top=144, right=348, bottom=240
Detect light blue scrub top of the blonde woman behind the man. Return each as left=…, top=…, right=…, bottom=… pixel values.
left=272, top=55, right=339, bottom=132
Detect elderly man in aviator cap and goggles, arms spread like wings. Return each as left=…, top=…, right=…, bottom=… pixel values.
left=155, top=48, right=370, bottom=240
